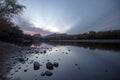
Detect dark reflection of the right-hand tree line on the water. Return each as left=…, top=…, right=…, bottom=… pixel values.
left=41, top=41, right=120, bottom=51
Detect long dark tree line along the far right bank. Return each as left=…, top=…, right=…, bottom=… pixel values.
left=43, top=30, right=120, bottom=40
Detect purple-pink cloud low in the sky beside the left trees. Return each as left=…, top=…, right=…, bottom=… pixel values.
left=13, top=15, right=52, bottom=36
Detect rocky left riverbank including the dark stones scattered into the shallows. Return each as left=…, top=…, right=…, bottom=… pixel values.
left=0, top=41, right=59, bottom=80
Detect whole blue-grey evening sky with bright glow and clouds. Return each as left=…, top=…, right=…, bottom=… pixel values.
left=13, top=0, right=120, bottom=36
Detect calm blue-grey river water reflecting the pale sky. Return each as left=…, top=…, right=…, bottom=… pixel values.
left=8, top=42, right=120, bottom=80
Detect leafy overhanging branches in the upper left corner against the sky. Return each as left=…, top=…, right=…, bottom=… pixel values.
left=0, top=0, right=25, bottom=19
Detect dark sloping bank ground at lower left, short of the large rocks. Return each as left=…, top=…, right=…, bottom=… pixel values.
left=0, top=41, right=25, bottom=80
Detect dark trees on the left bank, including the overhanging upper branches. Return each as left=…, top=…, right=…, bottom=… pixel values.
left=0, top=0, right=32, bottom=44
